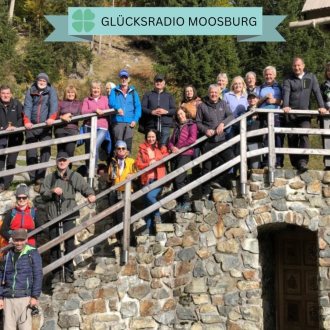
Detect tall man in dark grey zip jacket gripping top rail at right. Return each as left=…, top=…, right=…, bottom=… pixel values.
left=283, top=57, right=326, bottom=172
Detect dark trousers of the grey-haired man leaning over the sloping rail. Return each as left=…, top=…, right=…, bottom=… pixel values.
left=202, top=141, right=235, bottom=194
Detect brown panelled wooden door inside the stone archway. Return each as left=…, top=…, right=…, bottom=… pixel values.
left=276, top=229, right=319, bottom=330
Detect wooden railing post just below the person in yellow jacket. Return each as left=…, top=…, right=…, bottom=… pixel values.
left=121, top=181, right=132, bottom=264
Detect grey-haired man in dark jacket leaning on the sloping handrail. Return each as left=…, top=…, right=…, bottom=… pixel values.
left=196, top=84, right=234, bottom=198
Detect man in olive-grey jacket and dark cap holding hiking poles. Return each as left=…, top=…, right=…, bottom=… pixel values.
left=40, top=151, right=96, bottom=283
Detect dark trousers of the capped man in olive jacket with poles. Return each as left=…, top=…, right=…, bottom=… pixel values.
left=49, top=219, right=76, bottom=274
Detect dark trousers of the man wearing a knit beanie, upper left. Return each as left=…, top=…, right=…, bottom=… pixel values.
left=25, top=128, right=52, bottom=181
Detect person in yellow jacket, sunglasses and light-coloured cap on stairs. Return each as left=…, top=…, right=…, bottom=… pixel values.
left=108, top=140, right=137, bottom=235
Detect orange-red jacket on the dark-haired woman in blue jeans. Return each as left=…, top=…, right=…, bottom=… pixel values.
left=135, top=142, right=168, bottom=185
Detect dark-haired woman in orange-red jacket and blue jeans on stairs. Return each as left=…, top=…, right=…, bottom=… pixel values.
left=135, top=129, right=168, bottom=235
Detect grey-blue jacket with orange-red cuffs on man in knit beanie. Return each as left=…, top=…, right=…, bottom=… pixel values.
left=24, top=83, right=58, bottom=124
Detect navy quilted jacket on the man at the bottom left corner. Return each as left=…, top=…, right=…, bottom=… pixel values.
left=0, top=244, right=43, bottom=298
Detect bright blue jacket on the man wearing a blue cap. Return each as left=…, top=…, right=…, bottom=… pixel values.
left=109, top=85, right=141, bottom=124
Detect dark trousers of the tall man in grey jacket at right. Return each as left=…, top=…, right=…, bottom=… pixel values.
left=286, top=115, right=311, bottom=167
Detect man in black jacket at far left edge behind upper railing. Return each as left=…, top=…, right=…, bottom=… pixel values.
left=0, top=85, right=23, bottom=192
